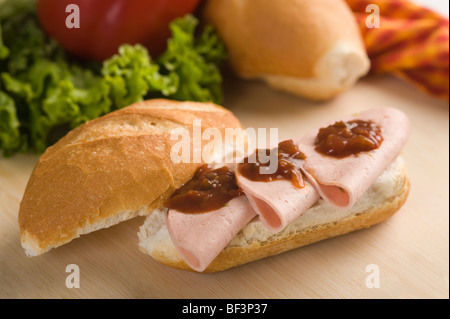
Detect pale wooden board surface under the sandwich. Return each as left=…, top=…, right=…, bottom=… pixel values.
left=0, top=73, right=449, bottom=298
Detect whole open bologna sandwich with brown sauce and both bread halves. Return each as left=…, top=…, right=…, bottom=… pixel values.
left=19, top=100, right=410, bottom=272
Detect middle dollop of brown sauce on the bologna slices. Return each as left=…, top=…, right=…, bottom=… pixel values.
left=237, top=140, right=306, bottom=188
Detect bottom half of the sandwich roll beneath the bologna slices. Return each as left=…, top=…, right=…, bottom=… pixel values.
left=138, top=157, right=410, bottom=273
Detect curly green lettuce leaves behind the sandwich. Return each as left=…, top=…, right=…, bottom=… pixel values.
left=0, top=0, right=226, bottom=156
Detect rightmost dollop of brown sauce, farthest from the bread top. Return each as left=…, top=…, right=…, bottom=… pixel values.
left=315, top=120, right=383, bottom=158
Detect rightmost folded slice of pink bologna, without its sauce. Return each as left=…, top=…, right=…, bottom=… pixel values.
left=298, top=108, right=410, bottom=209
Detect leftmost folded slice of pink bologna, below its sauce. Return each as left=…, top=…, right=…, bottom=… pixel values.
left=166, top=196, right=256, bottom=272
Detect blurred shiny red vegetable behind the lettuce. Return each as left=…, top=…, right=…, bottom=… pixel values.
left=37, top=0, right=200, bottom=61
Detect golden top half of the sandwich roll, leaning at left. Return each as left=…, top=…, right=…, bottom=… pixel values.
left=19, top=99, right=246, bottom=256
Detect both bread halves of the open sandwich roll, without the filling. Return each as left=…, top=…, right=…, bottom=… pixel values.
left=19, top=99, right=409, bottom=272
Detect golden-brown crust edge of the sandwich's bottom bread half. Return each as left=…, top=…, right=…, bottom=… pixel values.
left=151, top=168, right=410, bottom=273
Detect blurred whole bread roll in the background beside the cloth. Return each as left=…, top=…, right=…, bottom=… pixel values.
left=204, top=0, right=370, bottom=100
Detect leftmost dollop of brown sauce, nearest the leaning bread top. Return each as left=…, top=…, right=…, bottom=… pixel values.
left=165, top=164, right=244, bottom=214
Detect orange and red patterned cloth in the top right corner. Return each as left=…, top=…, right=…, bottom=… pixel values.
left=346, top=0, right=449, bottom=99
